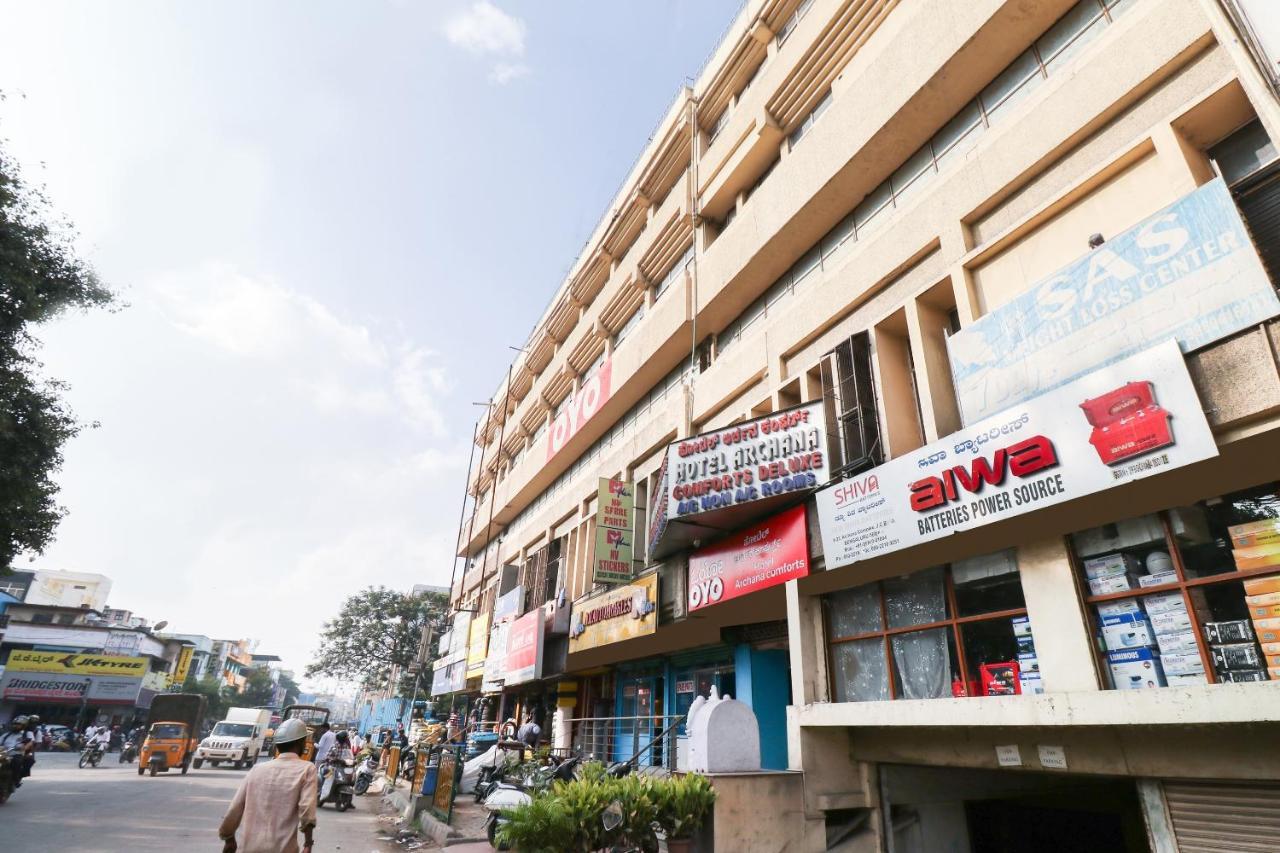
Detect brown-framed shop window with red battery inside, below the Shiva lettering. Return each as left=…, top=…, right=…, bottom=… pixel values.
left=824, top=551, right=1041, bottom=702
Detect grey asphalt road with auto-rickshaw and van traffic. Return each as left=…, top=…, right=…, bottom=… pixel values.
left=0, top=752, right=404, bottom=853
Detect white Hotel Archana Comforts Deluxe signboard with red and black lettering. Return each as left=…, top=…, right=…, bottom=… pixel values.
left=670, top=402, right=828, bottom=521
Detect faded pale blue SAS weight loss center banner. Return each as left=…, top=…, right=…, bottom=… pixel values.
left=947, top=179, right=1280, bottom=425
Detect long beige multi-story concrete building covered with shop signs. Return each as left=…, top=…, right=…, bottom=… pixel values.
left=433, top=0, right=1280, bottom=852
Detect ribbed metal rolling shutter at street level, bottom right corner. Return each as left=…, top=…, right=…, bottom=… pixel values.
left=1165, top=781, right=1280, bottom=853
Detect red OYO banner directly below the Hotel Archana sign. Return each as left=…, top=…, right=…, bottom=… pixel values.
left=689, top=505, right=809, bottom=612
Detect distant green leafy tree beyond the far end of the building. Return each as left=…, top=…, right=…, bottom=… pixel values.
left=307, top=587, right=449, bottom=693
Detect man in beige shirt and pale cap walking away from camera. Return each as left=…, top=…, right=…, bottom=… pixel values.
left=218, top=720, right=316, bottom=853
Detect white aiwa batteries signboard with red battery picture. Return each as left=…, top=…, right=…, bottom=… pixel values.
left=817, top=341, right=1217, bottom=569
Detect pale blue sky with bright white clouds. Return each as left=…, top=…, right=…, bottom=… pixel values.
left=0, top=0, right=740, bottom=674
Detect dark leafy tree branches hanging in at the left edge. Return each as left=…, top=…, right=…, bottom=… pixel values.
left=0, top=104, right=114, bottom=574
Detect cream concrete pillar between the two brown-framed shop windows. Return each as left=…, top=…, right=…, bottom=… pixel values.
left=1018, top=538, right=1100, bottom=693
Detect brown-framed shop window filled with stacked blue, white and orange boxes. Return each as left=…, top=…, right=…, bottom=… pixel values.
left=1071, top=483, right=1280, bottom=689
